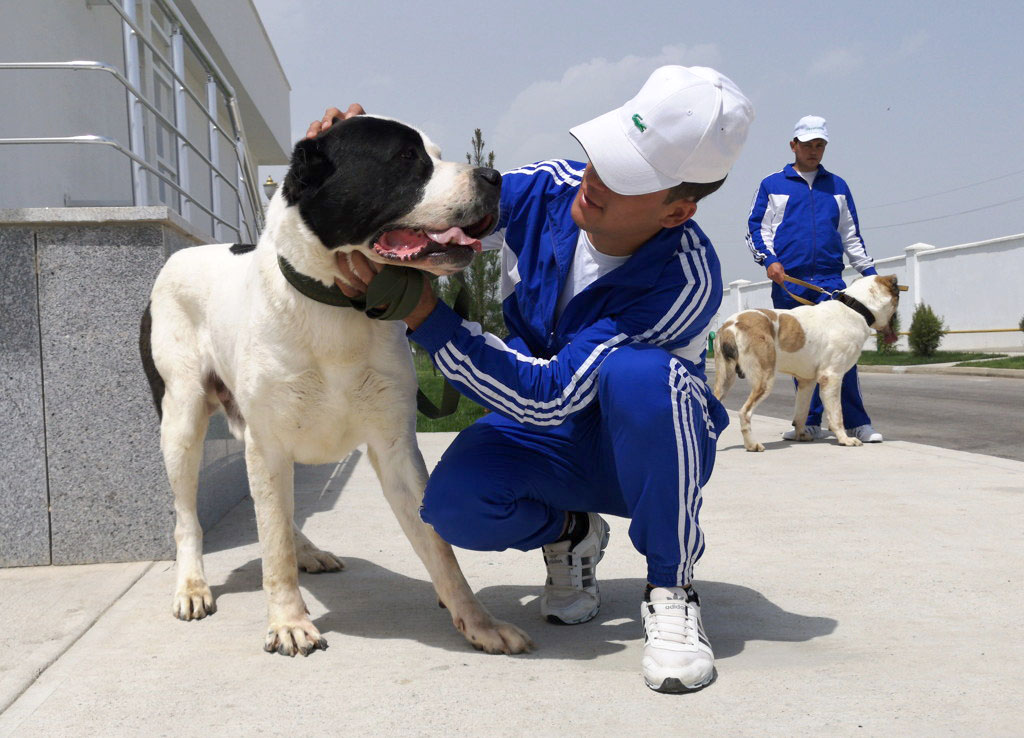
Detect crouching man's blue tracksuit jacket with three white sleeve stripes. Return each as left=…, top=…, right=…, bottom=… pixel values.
left=410, top=160, right=722, bottom=426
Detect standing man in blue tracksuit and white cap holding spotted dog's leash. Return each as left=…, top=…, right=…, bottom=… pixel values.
left=746, top=116, right=882, bottom=443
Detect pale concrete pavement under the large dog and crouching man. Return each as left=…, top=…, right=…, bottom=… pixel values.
left=0, top=417, right=1024, bottom=737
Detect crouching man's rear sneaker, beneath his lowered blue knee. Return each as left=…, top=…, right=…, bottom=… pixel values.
left=541, top=513, right=608, bottom=625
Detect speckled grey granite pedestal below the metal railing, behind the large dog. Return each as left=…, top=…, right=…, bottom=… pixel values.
left=0, top=207, right=248, bottom=566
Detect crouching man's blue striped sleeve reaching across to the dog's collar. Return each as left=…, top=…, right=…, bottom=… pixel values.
left=410, top=255, right=721, bottom=426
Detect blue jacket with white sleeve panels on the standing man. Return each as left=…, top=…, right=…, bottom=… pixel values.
left=746, top=164, right=877, bottom=281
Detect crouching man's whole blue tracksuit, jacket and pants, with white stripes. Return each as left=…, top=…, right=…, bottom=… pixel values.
left=411, top=160, right=728, bottom=587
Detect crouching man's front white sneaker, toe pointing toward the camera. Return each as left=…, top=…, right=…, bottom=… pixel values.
left=640, top=587, right=718, bottom=694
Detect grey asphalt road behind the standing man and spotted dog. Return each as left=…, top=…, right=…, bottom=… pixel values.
left=710, top=373, right=1024, bottom=461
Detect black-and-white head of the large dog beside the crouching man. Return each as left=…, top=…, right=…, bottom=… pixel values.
left=282, top=116, right=501, bottom=274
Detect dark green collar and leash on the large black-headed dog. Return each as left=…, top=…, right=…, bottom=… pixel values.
left=278, top=255, right=469, bottom=420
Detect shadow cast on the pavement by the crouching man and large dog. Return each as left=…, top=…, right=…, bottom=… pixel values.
left=212, top=557, right=838, bottom=660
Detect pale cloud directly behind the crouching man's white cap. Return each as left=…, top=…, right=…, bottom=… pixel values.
left=494, top=44, right=720, bottom=170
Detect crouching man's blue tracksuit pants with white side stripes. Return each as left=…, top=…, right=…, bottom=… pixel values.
left=421, top=344, right=729, bottom=587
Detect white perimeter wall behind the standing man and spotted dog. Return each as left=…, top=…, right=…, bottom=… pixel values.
left=712, top=233, right=1024, bottom=350
